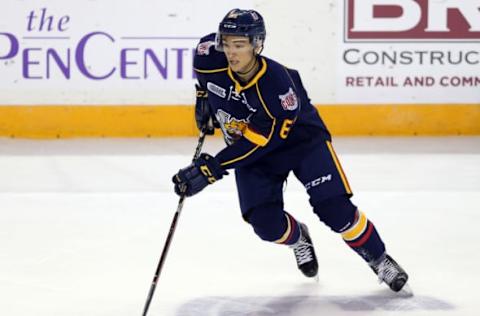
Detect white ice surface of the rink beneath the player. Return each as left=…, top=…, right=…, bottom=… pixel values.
left=0, top=137, right=480, bottom=316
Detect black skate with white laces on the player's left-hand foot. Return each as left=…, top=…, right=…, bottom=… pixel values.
left=290, top=223, right=318, bottom=278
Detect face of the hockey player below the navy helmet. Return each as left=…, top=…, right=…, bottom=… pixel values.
left=222, top=35, right=255, bottom=73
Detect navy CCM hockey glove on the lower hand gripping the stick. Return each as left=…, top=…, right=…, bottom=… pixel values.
left=172, top=153, right=228, bottom=196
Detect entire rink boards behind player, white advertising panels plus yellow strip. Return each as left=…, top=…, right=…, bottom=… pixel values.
left=0, top=0, right=480, bottom=138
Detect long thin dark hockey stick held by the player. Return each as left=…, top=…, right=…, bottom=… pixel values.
left=142, top=130, right=206, bottom=316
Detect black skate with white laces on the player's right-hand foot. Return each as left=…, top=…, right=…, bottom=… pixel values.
left=370, top=254, right=408, bottom=292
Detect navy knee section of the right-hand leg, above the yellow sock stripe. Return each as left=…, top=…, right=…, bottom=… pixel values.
left=314, top=195, right=357, bottom=233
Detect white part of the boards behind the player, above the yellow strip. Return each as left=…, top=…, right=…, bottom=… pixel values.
left=0, top=0, right=480, bottom=105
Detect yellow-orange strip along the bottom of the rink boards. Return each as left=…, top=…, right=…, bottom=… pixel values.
left=0, top=104, right=480, bottom=138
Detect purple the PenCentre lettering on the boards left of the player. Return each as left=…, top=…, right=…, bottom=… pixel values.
left=0, top=8, right=199, bottom=81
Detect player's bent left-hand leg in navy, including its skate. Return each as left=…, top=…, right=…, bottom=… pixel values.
left=235, top=167, right=318, bottom=277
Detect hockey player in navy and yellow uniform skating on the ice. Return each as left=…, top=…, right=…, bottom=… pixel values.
left=172, top=9, right=408, bottom=291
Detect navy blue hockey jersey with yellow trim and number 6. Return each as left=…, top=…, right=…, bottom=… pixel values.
left=194, top=33, right=330, bottom=170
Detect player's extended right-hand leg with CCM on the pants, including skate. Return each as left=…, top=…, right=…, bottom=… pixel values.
left=294, top=142, right=408, bottom=291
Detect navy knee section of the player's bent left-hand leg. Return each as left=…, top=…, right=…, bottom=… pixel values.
left=243, top=203, right=289, bottom=242
